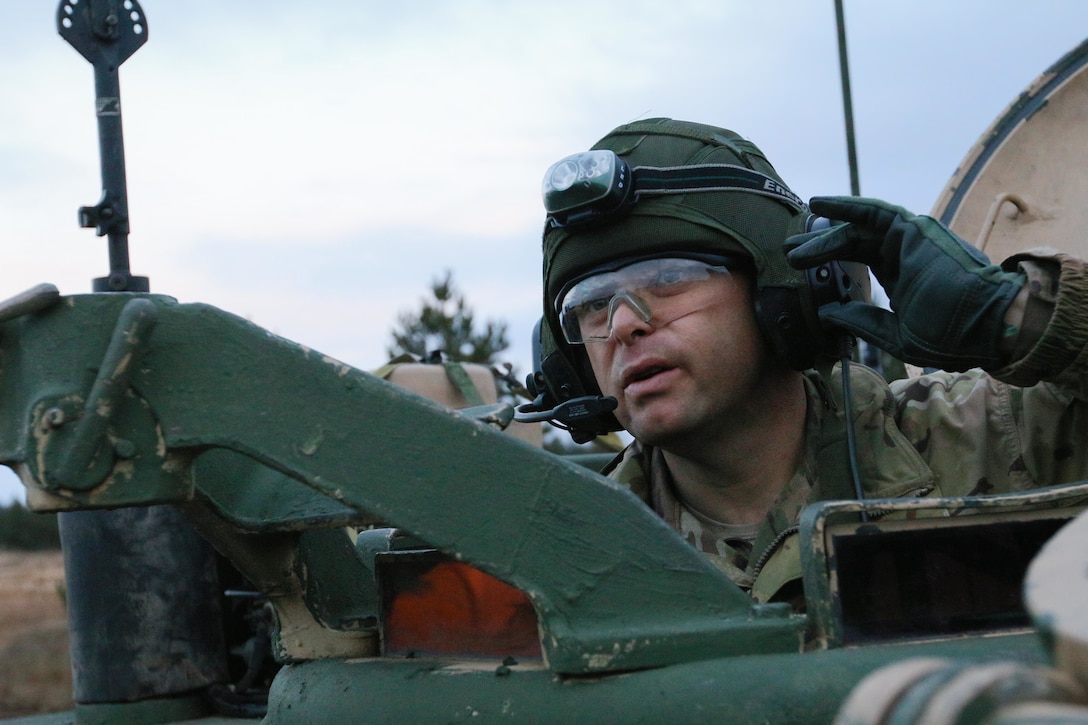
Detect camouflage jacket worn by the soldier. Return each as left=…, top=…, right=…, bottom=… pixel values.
left=608, top=248, right=1088, bottom=607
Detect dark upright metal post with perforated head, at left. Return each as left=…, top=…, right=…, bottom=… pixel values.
left=57, top=0, right=150, bottom=292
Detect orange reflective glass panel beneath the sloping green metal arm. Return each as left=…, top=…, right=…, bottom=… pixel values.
left=374, top=551, right=541, bottom=659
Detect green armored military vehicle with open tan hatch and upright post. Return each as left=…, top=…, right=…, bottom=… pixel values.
left=6, top=0, right=1088, bottom=725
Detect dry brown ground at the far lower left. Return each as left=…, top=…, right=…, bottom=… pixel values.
left=0, top=551, right=73, bottom=717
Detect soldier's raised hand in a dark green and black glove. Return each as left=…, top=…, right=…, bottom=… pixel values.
left=786, top=196, right=1026, bottom=370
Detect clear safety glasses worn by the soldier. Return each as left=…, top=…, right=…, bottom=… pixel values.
left=558, top=258, right=729, bottom=345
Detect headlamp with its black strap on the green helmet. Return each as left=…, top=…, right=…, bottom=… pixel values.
left=541, top=149, right=804, bottom=226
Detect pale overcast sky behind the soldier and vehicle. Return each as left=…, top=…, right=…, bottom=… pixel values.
left=0, top=0, right=1088, bottom=501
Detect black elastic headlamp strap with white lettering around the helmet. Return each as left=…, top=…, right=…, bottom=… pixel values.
left=631, top=163, right=805, bottom=212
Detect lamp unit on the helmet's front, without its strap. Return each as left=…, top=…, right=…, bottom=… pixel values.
left=541, top=149, right=631, bottom=224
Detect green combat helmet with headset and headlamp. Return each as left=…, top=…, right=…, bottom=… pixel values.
left=523, top=119, right=869, bottom=442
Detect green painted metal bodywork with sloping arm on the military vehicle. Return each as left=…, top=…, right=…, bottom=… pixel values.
left=0, top=262, right=1088, bottom=723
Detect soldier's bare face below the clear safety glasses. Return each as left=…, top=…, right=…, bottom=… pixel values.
left=585, top=269, right=780, bottom=450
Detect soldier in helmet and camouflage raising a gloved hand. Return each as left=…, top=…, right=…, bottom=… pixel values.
left=536, top=119, right=1088, bottom=609
